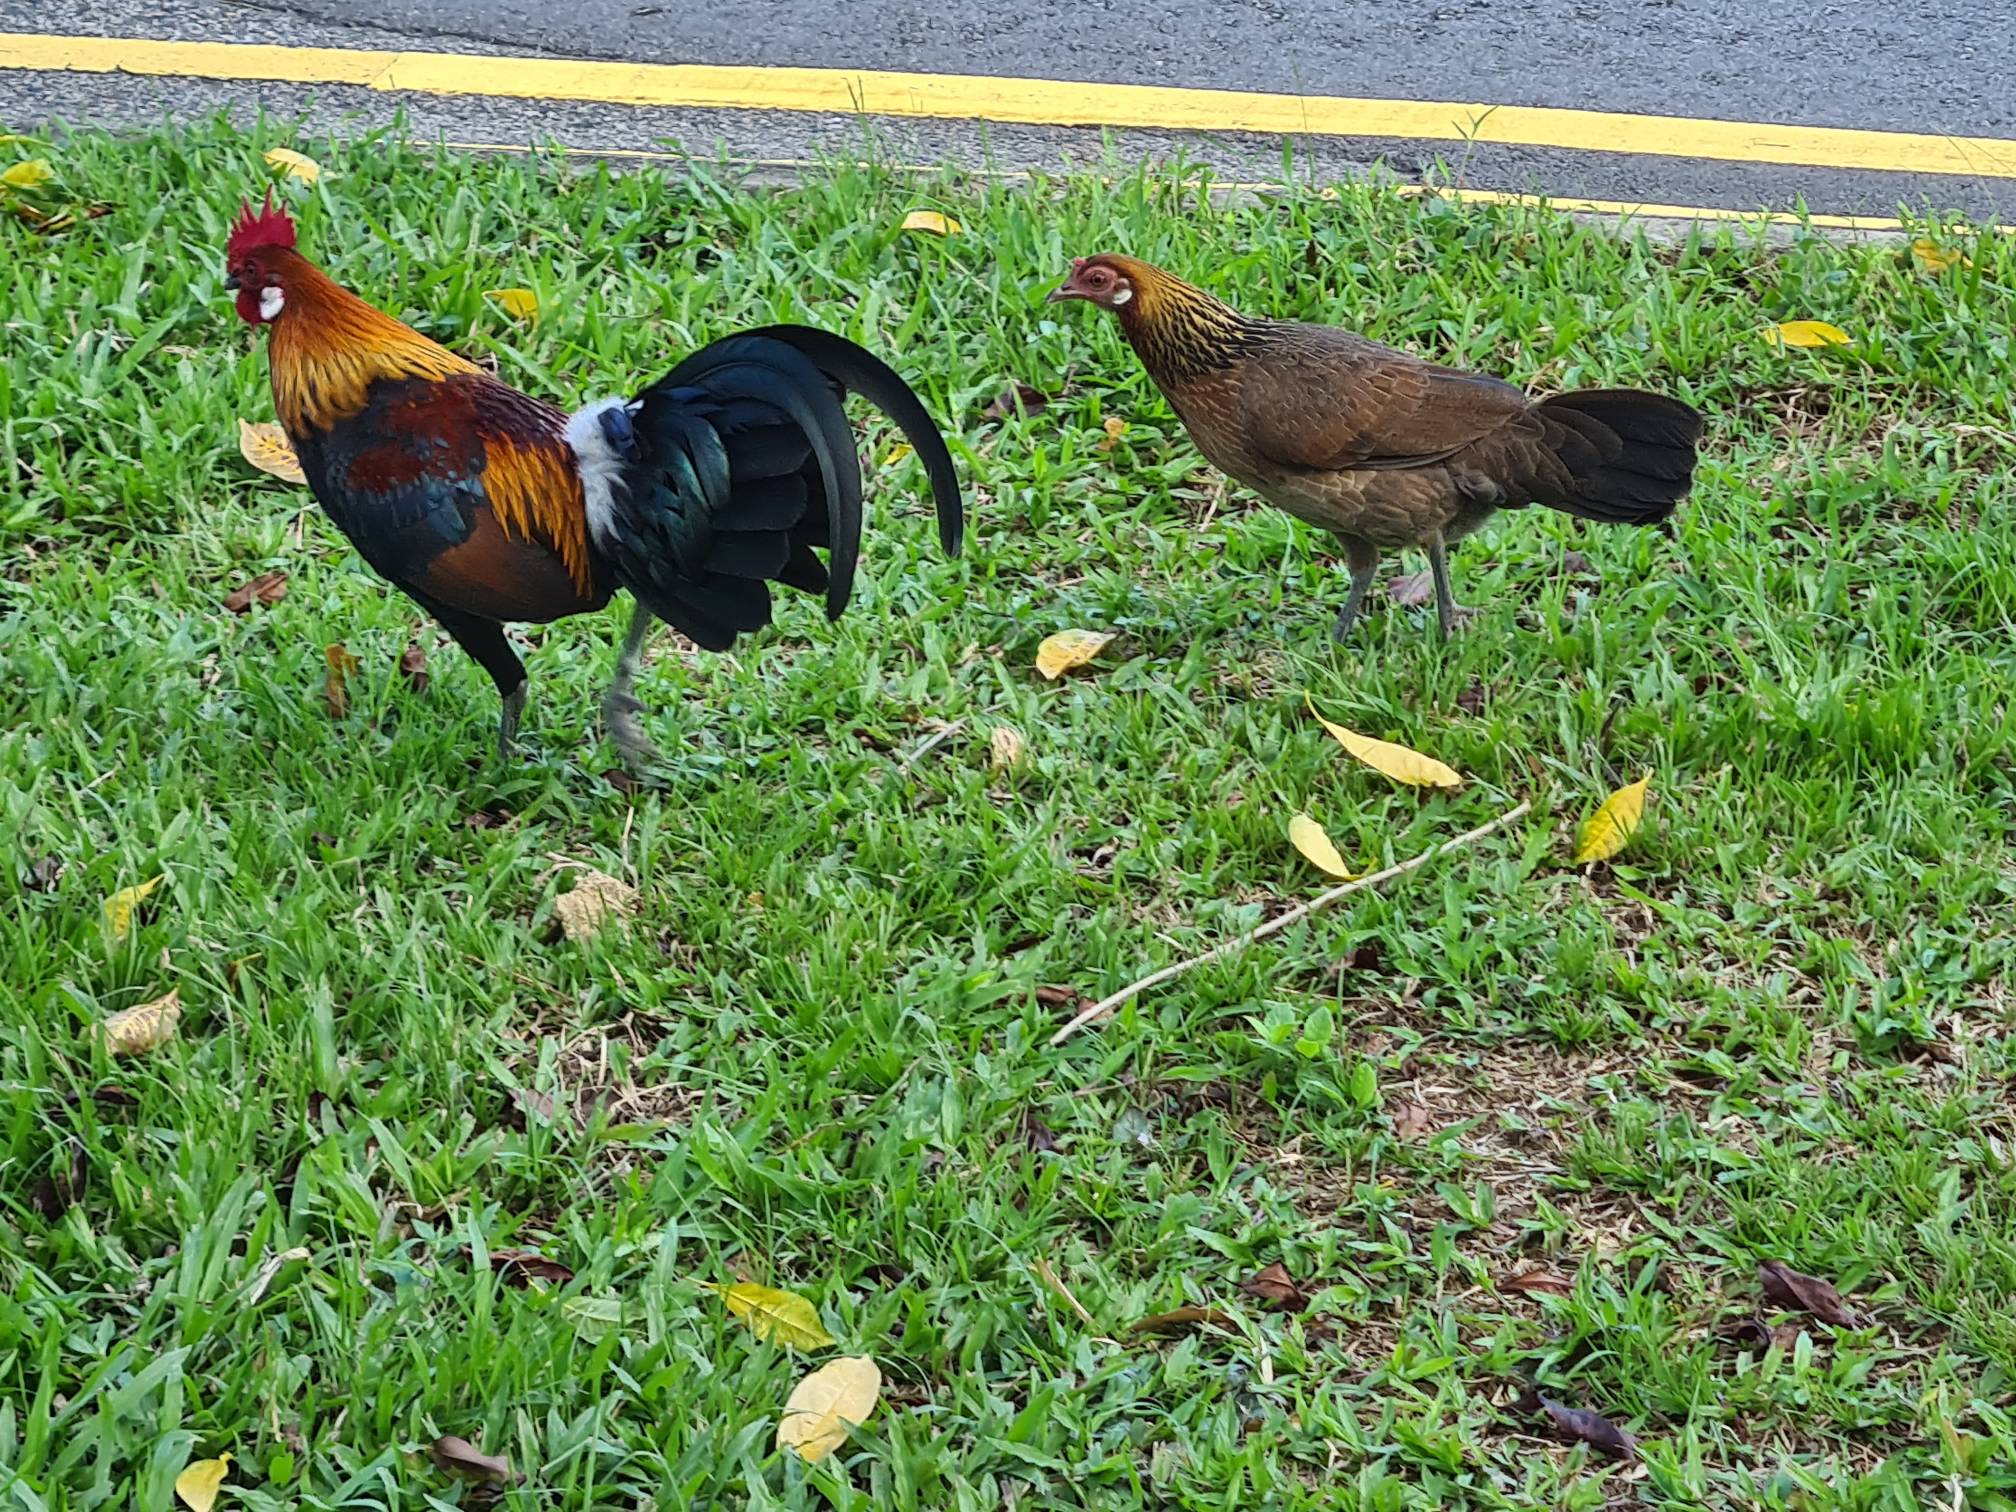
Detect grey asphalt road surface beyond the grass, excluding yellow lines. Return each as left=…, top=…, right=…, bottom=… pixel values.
left=0, top=0, right=2016, bottom=222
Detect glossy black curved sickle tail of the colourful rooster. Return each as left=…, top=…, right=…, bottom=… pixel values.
left=597, top=327, right=964, bottom=651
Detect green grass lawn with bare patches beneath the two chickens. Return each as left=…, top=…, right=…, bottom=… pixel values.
left=0, top=127, right=2016, bottom=1510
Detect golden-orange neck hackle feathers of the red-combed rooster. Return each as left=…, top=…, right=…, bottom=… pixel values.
left=268, top=252, right=480, bottom=431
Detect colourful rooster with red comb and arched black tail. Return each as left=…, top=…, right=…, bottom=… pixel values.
left=224, top=196, right=966, bottom=766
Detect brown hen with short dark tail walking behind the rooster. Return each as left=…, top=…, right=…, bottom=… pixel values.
left=1050, top=256, right=1702, bottom=641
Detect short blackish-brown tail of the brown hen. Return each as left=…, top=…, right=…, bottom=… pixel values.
left=1538, top=389, right=1702, bottom=524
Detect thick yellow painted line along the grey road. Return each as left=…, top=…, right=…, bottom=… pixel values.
left=0, top=32, right=2016, bottom=177
